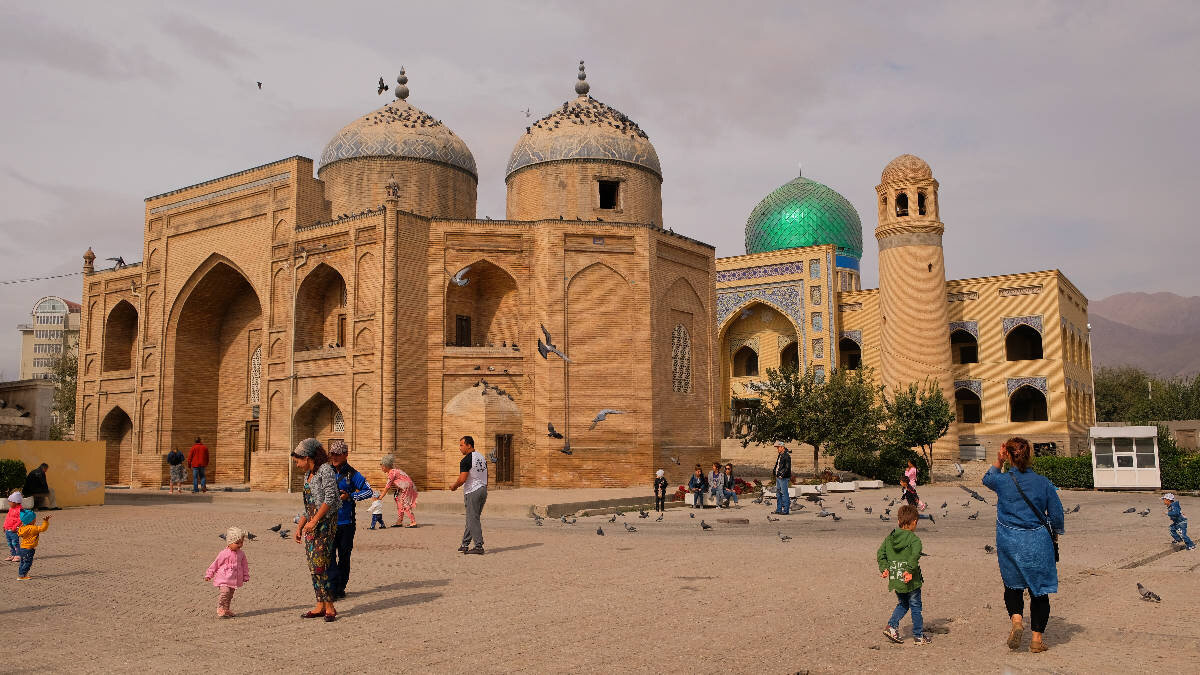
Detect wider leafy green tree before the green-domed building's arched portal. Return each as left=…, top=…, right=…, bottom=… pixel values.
left=742, top=368, right=883, bottom=471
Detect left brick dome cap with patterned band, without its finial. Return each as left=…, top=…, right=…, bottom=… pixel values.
left=317, top=97, right=479, bottom=178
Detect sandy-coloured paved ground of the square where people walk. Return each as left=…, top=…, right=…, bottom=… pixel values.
left=0, top=486, right=1200, bottom=673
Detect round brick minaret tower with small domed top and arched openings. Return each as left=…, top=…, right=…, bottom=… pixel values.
left=875, top=155, right=959, bottom=460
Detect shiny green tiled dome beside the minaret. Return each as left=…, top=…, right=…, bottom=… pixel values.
left=746, top=177, right=863, bottom=259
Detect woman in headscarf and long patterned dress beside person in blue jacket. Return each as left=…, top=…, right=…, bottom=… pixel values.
left=292, top=438, right=337, bottom=621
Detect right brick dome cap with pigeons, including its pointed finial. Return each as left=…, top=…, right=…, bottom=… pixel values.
left=504, top=61, right=662, bottom=180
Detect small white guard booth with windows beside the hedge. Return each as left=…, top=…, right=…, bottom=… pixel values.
left=1088, top=426, right=1162, bottom=490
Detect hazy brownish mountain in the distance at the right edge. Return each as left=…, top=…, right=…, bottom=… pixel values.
left=1088, top=293, right=1200, bottom=377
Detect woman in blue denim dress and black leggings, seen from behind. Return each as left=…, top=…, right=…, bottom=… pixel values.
left=983, top=437, right=1063, bottom=653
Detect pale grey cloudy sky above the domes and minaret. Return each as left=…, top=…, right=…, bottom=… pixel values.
left=0, top=0, right=1200, bottom=372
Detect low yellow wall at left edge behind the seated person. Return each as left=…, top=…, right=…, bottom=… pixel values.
left=0, top=441, right=104, bottom=507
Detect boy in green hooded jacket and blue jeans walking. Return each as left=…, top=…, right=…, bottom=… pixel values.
left=875, top=504, right=932, bottom=645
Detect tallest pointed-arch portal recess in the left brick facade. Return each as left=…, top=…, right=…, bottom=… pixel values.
left=164, top=258, right=263, bottom=483
